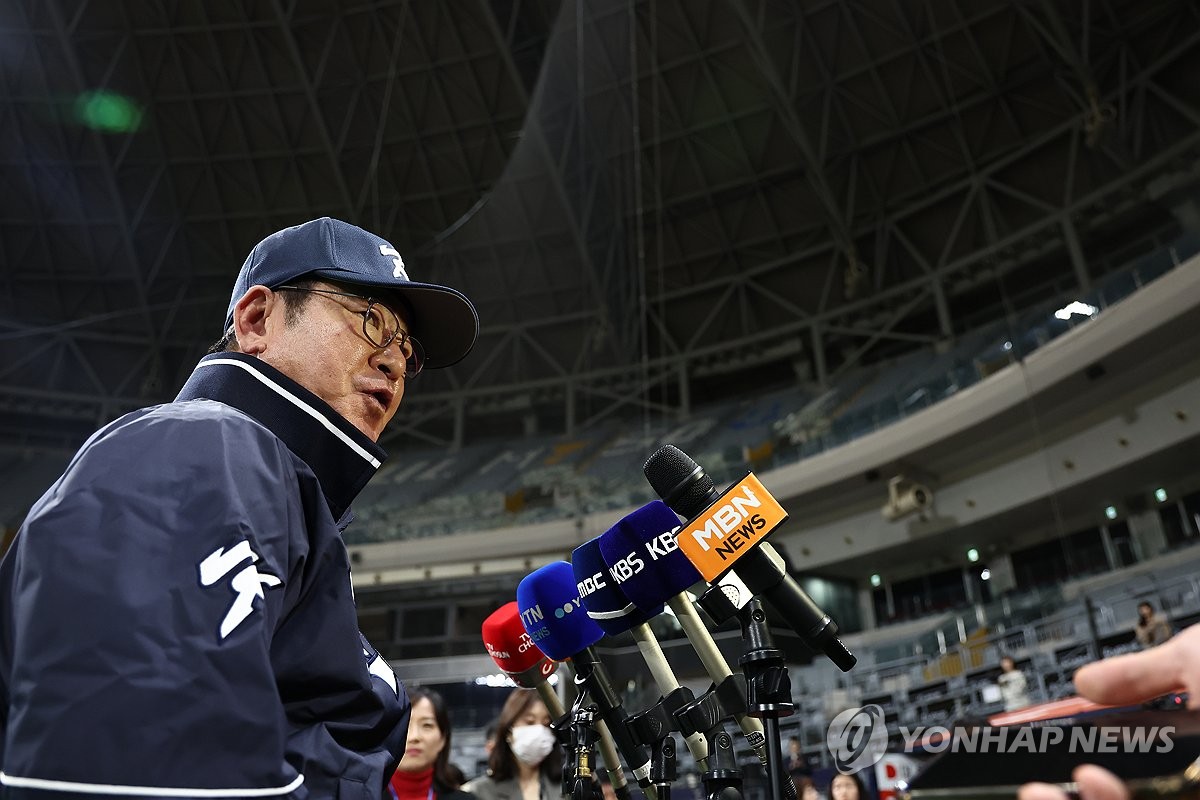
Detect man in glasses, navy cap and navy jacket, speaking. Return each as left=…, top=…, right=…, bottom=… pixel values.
left=0, top=218, right=479, bottom=800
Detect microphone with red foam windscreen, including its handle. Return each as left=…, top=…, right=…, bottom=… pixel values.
left=482, top=600, right=630, bottom=800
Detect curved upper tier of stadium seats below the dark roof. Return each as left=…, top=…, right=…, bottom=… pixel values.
left=347, top=227, right=1200, bottom=545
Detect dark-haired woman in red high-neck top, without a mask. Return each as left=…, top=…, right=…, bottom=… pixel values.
left=389, top=687, right=470, bottom=800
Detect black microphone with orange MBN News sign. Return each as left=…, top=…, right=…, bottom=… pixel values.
left=642, top=445, right=858, bottom=672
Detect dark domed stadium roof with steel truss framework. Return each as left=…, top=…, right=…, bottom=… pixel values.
left=0, top=0, right=1200, bottom=450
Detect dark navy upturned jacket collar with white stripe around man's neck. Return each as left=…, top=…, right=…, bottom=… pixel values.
left=175, top=353, right=388, bottom=525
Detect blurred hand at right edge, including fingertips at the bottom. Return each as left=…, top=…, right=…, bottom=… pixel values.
left=1016, top=624, right=1200, bottom=800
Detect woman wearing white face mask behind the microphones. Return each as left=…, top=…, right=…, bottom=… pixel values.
left=462, top=688, right=563, bottom=800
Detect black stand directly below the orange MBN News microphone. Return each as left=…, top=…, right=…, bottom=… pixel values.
left=738, top=597, right=796, bottom=800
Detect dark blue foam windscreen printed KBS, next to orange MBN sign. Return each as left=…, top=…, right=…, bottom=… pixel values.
left=600, top=500, right=701, bottom=608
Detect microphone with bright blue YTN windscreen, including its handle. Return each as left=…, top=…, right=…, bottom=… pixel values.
left=517, top=561, right=654, bottom=795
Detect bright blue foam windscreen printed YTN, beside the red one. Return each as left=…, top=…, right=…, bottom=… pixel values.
left=517, top=561, right=604, bottom=661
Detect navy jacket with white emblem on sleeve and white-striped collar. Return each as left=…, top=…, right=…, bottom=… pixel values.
left=0, top=353, right=409, bottom=800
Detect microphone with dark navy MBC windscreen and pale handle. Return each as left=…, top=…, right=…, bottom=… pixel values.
left=571, top=534, right=708, bottom=769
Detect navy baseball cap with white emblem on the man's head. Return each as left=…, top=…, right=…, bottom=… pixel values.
left=223, top=217, right=479, bottom=369
